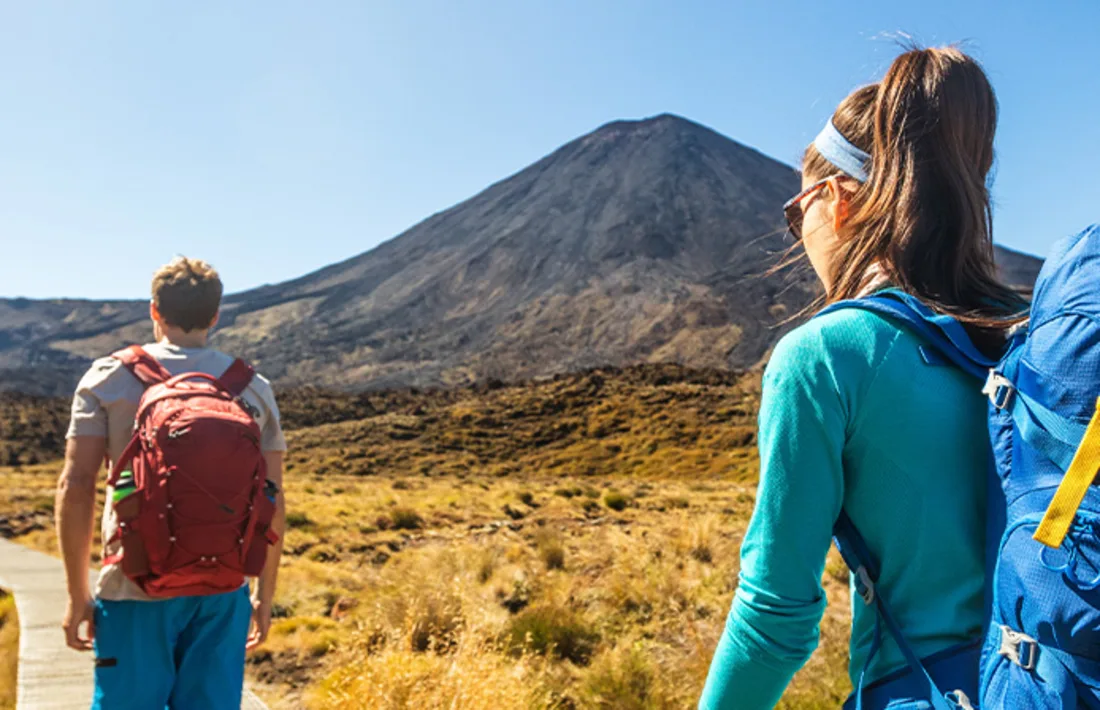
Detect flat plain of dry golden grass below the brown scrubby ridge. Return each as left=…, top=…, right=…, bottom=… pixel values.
left=0, top=466, right=849, bottom=710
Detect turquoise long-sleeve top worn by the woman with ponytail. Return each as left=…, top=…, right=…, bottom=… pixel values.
left=700, top=309, right=989, bottom=710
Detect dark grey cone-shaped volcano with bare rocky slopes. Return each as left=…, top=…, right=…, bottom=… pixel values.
left=0, top=116, right=1037, bottom=391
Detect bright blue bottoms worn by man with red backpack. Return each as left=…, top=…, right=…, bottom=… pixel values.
left=91, top=587, right=252, bottom=710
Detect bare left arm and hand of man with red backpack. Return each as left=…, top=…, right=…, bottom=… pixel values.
left=54, top=436, right=107, bottom=651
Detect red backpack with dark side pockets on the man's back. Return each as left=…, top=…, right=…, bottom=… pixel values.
left=103, top=346, right=278, bottom=597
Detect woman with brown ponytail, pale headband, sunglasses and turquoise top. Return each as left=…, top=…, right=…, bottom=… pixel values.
left=700, top=48, right=1022, bottom=710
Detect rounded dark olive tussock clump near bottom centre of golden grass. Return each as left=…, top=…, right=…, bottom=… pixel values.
left=505, top=604, right=600, bottom=666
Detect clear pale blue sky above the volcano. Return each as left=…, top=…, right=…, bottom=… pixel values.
left=0, top=0, right=1100, bottom=297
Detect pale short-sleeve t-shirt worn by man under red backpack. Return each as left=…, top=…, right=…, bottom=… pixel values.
left=66, top=343, right=286, bottom=601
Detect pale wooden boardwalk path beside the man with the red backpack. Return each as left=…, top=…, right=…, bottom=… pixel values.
left=0, top=539, right=266, bottom=710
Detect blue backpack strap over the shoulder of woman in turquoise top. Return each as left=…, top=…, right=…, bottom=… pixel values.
left=817, top=288, right=997, bottom=382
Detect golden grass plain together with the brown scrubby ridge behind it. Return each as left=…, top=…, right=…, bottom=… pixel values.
left=0, top=367, right=849, bottom=710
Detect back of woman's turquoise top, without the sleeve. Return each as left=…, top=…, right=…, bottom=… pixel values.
left=807, top=312, right=989, bottom=680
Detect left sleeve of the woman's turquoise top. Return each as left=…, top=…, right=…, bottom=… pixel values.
left=699, top=323, right=849, bottom=710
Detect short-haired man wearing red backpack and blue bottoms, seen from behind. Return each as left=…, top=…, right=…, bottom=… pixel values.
left=56, top=258, right=286, bottom=710
